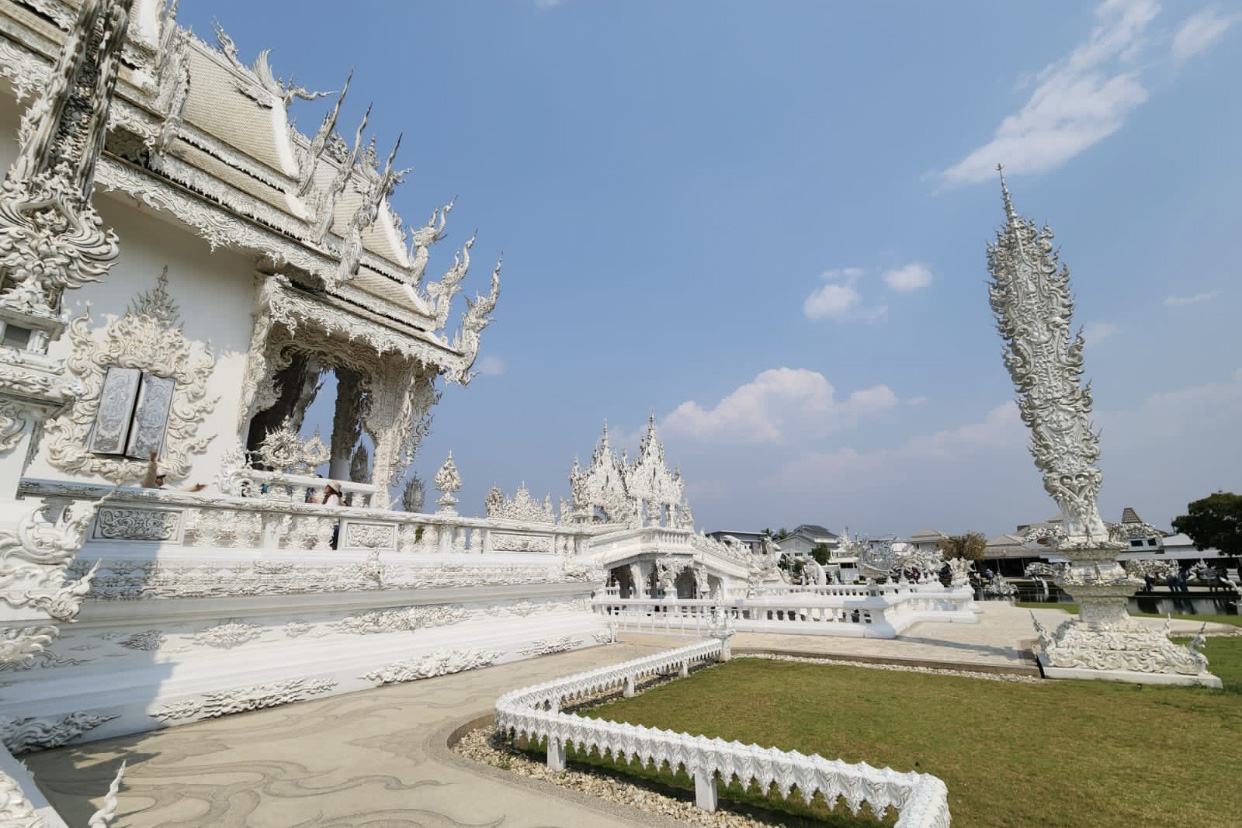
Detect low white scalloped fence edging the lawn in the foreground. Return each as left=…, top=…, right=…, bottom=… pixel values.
left=496, top=639, right=949, bottom=828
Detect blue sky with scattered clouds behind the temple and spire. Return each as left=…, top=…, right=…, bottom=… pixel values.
left=179, top=0, right=1242, bottom=535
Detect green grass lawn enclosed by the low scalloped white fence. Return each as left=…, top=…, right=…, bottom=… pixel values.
left=541, top=638, right=1242, bottom=828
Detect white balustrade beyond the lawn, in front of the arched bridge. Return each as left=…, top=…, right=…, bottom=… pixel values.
left=592, top=585, right=976, bottom=638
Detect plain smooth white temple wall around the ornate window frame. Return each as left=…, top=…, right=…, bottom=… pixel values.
left=26, top=194, right=256, bottom=488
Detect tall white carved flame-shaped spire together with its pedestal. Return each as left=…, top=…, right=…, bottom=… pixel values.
left=987, top=168, right=1221, bottom=686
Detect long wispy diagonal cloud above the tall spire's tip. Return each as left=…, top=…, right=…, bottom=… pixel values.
left=941, top=0, right=1160, bottom=184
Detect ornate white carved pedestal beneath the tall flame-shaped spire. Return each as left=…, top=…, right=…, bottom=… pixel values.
left=1035, top=544, right=1221, bottom=688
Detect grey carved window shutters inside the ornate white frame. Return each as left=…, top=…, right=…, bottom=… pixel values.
left=88, top=365, right=176, bottom=459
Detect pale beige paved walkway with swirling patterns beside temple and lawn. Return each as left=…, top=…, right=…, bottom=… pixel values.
left=26, top=605, right=1237, bottom=828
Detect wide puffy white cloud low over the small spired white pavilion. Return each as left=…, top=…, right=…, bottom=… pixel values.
left=660, top=367, right=898, bottom=443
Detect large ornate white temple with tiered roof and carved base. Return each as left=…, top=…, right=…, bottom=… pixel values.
left=0, top=0, right=618, bottom=824
